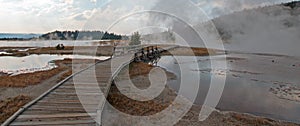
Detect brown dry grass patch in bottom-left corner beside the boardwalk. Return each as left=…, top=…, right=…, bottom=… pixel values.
left=0, top=95, right=31, bottom=123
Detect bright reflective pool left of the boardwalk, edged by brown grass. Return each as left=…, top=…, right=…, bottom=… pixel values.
left=0, top=54, right=109, bottom=75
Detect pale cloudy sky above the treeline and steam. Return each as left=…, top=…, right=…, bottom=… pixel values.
left=0, top=0, right=291, bottom=33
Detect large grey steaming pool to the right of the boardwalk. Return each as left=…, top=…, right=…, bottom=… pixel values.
left=158, top=54, right=300, bottom=123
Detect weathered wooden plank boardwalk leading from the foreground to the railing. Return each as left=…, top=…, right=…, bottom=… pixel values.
left=2, top=47, right=174, bottom=126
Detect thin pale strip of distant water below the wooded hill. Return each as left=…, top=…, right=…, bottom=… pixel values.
left=0, top=40, right=108, bottom=47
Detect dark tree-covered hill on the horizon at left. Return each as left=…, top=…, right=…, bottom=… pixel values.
left=38, top=31, right=128, bottom=40
